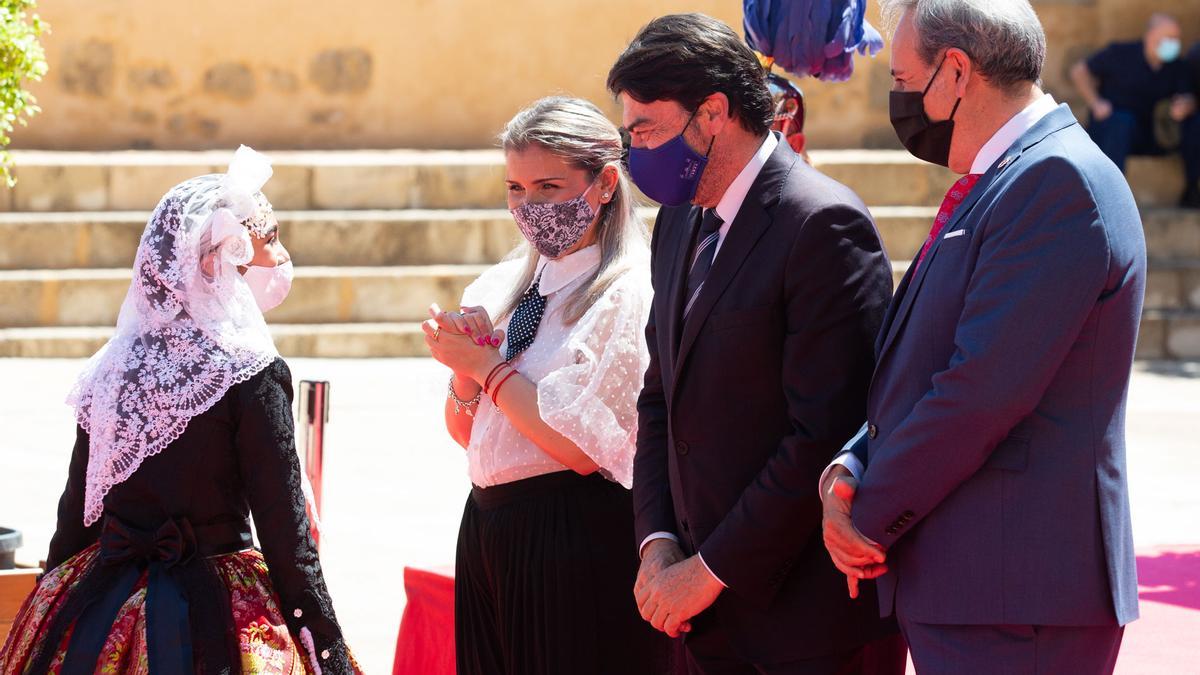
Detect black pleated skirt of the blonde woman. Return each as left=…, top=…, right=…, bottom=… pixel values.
left=455, top=471, right=670, bottom=675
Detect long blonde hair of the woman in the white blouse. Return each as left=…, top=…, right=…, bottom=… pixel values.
left=497, top=96, right=649, bottom=324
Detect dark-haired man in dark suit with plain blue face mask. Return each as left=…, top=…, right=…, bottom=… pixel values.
left=608, top=14, right=905, bottom=675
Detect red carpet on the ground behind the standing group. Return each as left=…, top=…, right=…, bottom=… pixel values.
left=392, top=546, right=1200, bottom=675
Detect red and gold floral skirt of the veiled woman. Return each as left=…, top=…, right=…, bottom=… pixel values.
left=0, top=544, right=324, bottom=675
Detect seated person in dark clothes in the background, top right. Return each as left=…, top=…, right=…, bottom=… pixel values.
left=1070, top=13, right=1200, bottom=208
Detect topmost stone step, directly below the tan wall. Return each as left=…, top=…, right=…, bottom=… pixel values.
left=0, top=150, right=1183, bottom=211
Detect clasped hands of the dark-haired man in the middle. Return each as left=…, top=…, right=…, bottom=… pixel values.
left=634, top=539, right=725, bottom=638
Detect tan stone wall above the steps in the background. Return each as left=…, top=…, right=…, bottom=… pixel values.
left=14, top=0, right=1200, bottom=150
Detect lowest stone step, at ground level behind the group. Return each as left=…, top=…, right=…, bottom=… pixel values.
left=0, top=310, right=1200, bottom=360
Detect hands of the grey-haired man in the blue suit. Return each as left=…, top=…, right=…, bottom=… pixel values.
left=821, top=465, right=888, bottom=598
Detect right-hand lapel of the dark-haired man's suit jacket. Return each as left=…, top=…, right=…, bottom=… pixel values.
left=676, top=142, right=799, bottom=382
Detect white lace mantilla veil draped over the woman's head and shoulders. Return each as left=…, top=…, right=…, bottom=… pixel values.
left=68, top=147, right=278, bottom=525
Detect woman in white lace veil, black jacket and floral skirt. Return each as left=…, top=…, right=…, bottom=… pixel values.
left=0, top=148, right=360, bottom=675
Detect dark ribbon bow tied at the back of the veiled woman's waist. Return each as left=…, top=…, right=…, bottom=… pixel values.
left=62, top=518, right=196, bottom=675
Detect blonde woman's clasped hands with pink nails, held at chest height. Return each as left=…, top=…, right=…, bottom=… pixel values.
left=421, top=303, right=504, bottom=386
